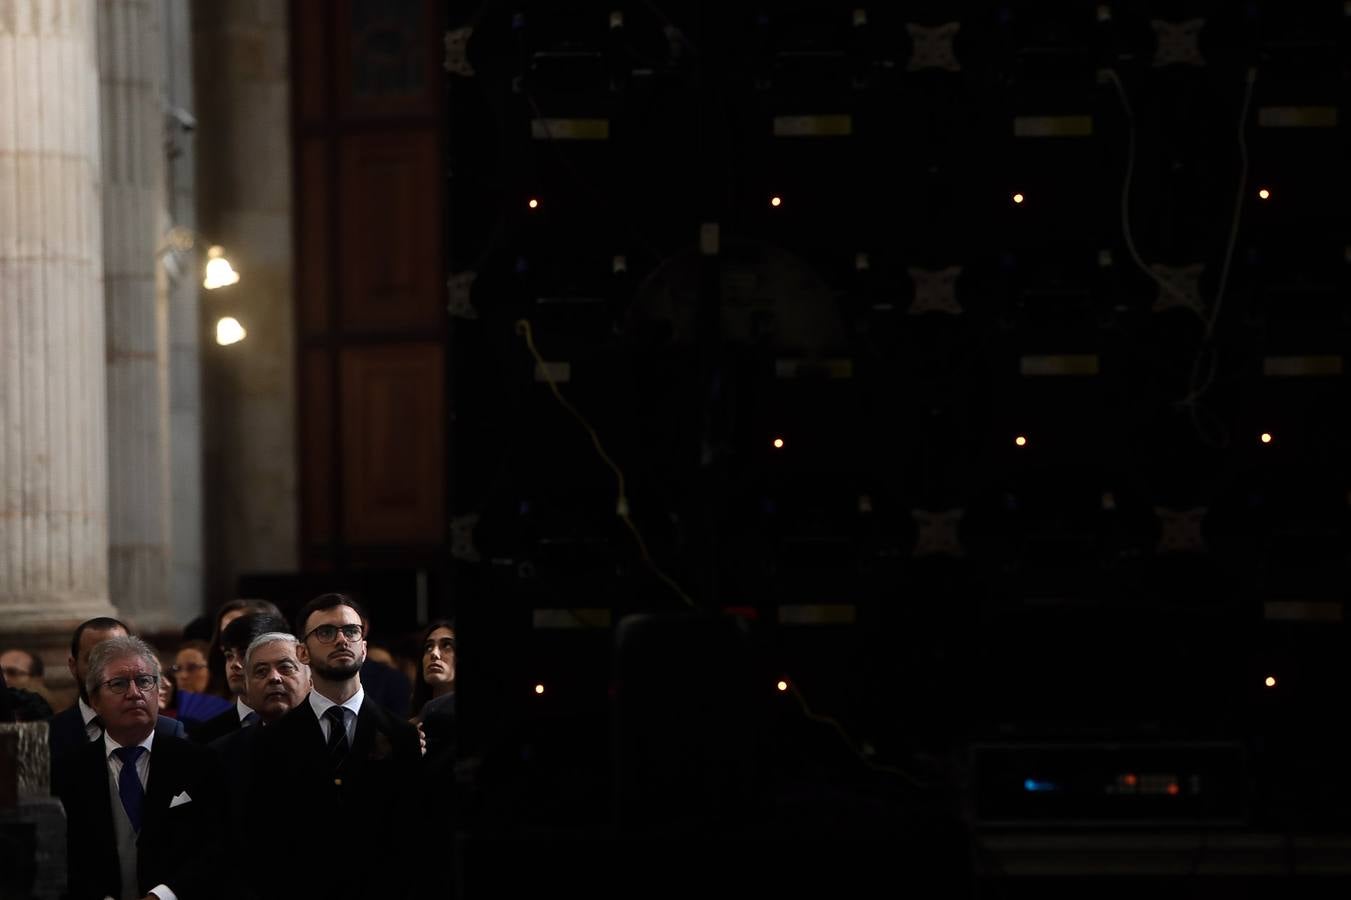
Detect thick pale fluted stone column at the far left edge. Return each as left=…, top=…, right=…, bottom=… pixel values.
left=0, top=0, right=112, bottom=689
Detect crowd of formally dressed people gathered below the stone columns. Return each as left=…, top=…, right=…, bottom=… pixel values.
left=0, top=593, right=455, bottom=900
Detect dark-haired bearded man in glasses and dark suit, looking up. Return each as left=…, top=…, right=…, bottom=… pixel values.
left=250, top=593, right=422, bottom=900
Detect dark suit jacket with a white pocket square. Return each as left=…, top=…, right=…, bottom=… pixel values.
left=61, top=734, right=224, bottom=900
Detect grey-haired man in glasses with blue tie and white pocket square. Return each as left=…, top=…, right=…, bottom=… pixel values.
left=61, top=635, right=224, bottom=900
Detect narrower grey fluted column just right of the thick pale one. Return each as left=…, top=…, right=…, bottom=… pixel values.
left=99, top=0, right=181, bottom=631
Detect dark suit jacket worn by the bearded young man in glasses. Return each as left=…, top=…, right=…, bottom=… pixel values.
left=250, top=695, right=418, bottom=900
